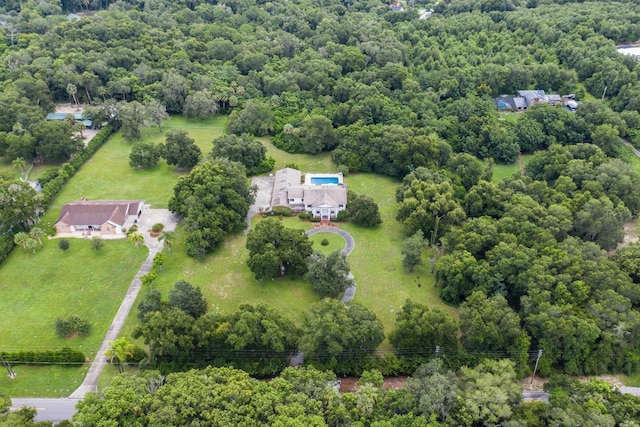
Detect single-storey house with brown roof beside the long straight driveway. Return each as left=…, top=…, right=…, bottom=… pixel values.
left=54, top=199, right=144, bottom=235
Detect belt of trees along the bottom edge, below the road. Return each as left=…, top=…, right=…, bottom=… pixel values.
left=66, top=360, right=640, bottom=427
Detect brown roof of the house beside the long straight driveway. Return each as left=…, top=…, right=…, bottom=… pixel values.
left=57, top=200, right=143, bottom=226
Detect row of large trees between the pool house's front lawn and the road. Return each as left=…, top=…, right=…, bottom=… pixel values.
left=134, top=280, right=553, bottom=376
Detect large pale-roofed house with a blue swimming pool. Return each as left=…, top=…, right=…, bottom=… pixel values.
left=271, top=168, right=347, bottom=220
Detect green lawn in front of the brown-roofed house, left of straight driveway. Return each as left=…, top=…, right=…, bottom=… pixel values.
left=0, top=239, right=147, bottom=396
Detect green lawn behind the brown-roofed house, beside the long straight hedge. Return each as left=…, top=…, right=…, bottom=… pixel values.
left=47, top=116, right=227, bottom=212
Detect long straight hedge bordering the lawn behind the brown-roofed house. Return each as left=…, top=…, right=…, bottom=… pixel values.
left=40, top=126, right=114, bottom=206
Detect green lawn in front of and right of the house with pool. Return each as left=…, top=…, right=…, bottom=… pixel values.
left=123, top=169, right=456, bottom=354
